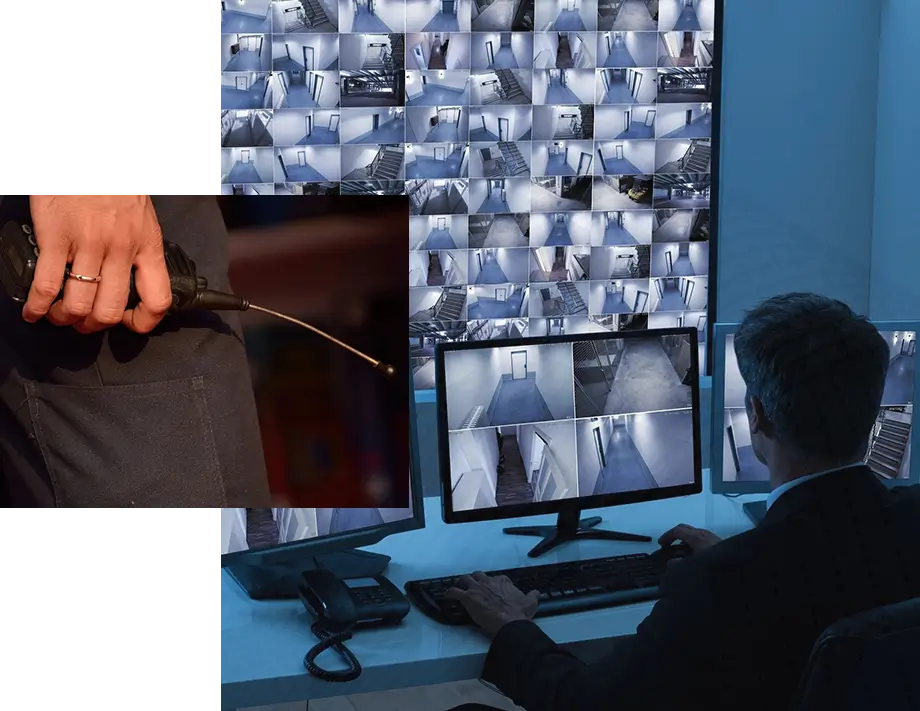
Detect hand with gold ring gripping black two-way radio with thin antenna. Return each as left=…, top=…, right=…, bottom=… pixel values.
left=0, top=193, right=396, bottom=378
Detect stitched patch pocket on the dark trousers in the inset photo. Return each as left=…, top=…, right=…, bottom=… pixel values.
left=25, top=376, right=226, bottom=511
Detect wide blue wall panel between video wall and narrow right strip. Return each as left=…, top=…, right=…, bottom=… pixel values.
left=716, top=0, right=880, bottom=321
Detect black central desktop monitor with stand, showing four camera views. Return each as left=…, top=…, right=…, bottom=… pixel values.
left=436, top=328, right=702, bottom=557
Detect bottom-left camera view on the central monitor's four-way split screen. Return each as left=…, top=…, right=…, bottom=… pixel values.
left=449, top=422, right=579, bottom=511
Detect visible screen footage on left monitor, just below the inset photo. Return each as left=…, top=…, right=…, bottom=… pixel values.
left=217, top=478, right=412, bottom=555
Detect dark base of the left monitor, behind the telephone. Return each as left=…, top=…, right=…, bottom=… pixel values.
left=225, top=550, right=390, bottom=600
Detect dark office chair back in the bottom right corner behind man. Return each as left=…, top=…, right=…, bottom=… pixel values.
left=793, top=598, right=920, bottom=711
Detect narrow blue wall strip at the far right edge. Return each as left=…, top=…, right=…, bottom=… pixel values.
left=869, top=0, right=920, bottom=321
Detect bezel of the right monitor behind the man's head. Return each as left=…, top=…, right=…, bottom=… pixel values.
left=709, top=319, right=920, bottom=496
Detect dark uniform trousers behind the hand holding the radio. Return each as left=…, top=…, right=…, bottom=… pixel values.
left=0, top=193, right=270, bottom=511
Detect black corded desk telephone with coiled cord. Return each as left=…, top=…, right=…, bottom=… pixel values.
left=297, top=568, right=409, bottom=681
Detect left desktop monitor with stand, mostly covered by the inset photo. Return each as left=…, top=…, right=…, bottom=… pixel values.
left=217, top=372, right=425, bottom=600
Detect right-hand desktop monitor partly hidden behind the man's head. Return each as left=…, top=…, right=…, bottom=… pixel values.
left=710, top=321, right=920, bottom=498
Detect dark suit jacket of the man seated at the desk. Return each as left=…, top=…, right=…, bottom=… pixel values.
left=483, top=467, right=920, bottom=711
